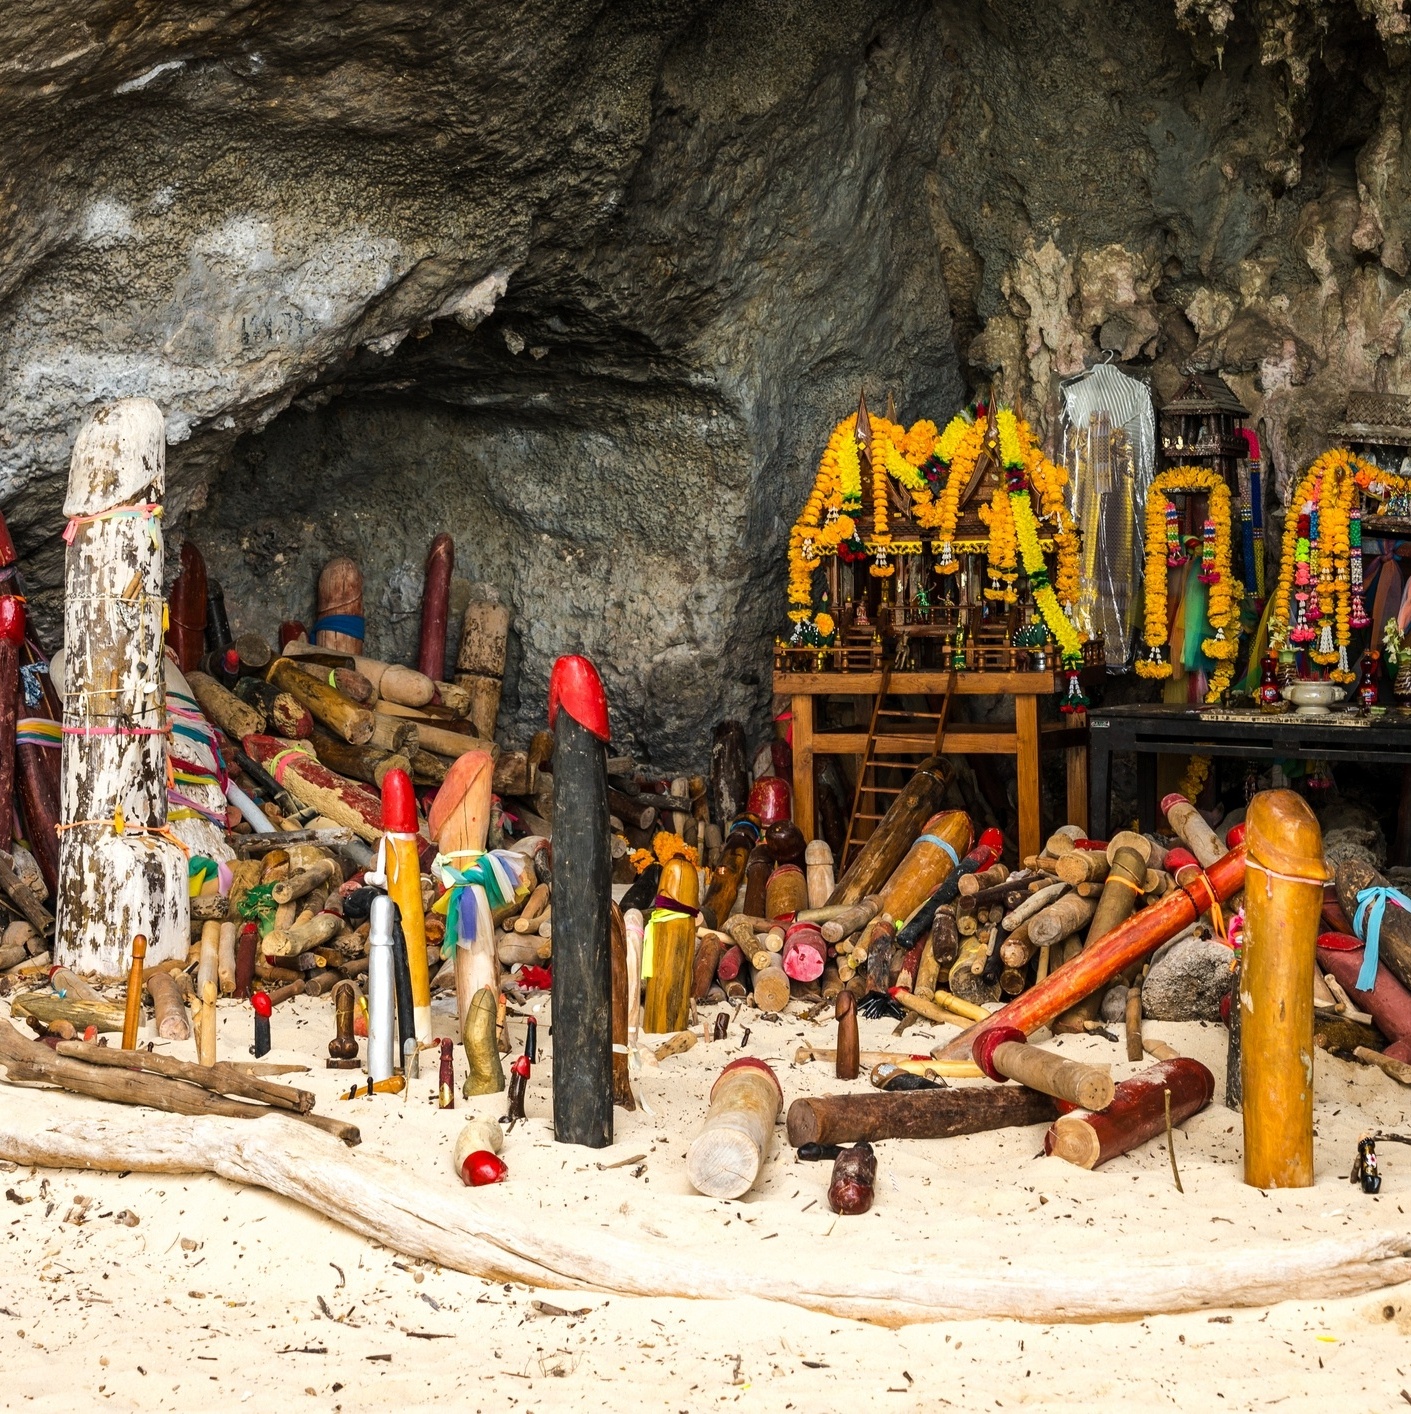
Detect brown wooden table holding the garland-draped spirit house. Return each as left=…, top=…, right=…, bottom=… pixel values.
left=773, top=672, right=1087, bottom=858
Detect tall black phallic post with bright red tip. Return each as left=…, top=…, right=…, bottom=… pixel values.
left=549, top=656, right=616, bottom=1148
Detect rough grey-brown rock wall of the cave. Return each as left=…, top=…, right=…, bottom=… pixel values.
left=0, top=0, right=1411, bottom=765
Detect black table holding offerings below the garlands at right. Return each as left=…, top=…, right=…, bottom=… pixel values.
left=1087, top=703, right=1411, bottom=840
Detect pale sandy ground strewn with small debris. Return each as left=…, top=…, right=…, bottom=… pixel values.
left=0, top=998, right=1411, bottom=1414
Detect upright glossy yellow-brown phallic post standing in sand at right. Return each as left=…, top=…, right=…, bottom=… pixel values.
left=1239, top=790, right=1328, bottom=1188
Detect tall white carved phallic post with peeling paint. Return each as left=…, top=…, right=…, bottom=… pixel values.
left=54, top=397, right=191, bottom=977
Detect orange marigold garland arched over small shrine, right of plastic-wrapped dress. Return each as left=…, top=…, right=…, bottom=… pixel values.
left=1137, top=467, right=1244, bottom=681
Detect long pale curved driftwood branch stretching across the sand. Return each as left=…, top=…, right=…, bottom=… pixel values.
left=0, top=1106, right=1411, bottom=1326
